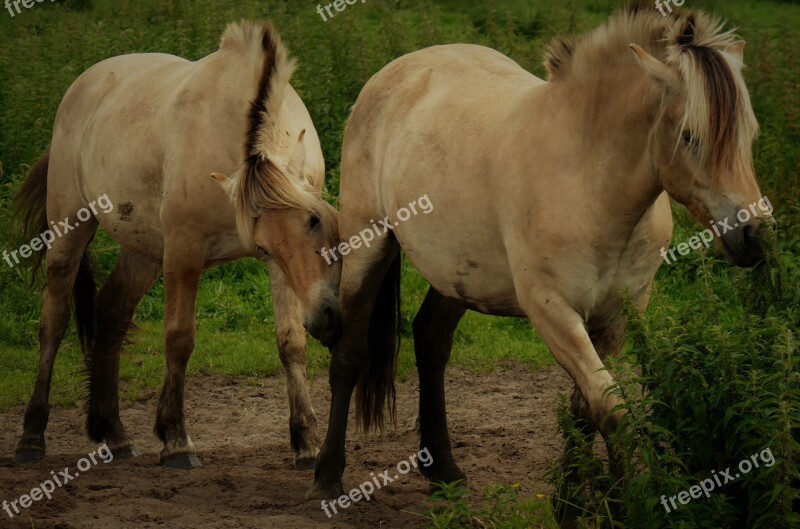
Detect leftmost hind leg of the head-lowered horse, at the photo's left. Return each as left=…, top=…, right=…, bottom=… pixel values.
left=14, top=222, right=97, bottom=464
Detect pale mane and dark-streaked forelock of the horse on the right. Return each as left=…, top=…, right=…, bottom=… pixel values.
left=544, top=3, right=758, bottom=174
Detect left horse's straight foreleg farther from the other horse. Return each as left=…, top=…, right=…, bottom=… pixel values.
left=155, top=245, right=205, bottom=468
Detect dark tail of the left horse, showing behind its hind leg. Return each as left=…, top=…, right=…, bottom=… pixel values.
left=13, top=147, right=97, bottom=359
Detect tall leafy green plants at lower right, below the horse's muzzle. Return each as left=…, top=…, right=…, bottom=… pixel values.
left=552, top=222, right=800, bottom=529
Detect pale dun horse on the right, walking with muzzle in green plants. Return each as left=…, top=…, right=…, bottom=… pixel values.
left=307, top=8, right=773, bottom=499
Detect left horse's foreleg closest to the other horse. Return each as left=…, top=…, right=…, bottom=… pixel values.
left=269, top=263, right=321, bottom=470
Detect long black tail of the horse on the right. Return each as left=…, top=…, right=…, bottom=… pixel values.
left=356, top=252, right=401, bottom=431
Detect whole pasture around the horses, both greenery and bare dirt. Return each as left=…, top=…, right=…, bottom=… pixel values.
left=0, top=0, right=800, bottom=529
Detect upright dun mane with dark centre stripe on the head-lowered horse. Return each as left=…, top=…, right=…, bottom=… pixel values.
left=220, top=21, right=321, bottom=249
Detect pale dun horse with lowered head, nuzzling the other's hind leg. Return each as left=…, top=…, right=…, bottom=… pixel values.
left=16, top=22, right=341, bottom=468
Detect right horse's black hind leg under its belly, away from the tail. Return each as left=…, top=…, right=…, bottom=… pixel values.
left=413, top=288, right=466, bottom=486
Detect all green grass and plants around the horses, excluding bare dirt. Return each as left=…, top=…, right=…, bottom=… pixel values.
left=0, top=0, right=800, bottom=528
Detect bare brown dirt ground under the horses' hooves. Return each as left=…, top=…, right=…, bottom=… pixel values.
left=0, top=364, right=570, bottom=529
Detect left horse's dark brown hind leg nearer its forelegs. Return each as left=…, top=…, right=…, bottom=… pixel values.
left=86, top=249, right=161, bottom=459
